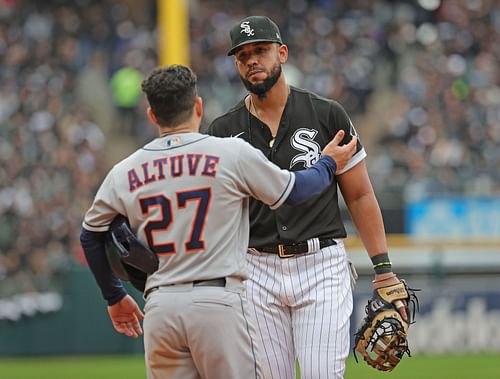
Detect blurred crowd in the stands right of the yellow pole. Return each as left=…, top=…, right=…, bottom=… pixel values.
left=188, top=0, right=500, bottom=202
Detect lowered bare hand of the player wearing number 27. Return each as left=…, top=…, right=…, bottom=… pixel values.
left=108, top=295, right=144, bottom=338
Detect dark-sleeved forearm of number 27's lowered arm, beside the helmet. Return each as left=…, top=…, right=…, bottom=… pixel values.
left=80, top=228, right=127, bottom=305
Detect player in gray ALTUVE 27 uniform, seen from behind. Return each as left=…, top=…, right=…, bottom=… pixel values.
left=80, top=65, right=356, bottom=379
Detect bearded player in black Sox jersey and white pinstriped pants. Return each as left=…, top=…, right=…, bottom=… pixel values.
left=208, top=16, right=404, bottom=379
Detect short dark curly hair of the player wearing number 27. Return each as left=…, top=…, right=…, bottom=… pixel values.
left=142, top=65, right=198, bottom=128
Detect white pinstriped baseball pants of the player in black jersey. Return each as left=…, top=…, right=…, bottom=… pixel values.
left=246, top=241, right=353, bottom=379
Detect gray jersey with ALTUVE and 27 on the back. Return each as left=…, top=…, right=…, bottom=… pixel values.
left=83, top=133, right=295, bottom=288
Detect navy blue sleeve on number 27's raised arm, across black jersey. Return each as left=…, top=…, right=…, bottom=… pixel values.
left=285, top=156, right=337, bottom=205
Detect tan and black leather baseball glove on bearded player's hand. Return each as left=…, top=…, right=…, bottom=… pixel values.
left=353, top=280, right=418, bottom=371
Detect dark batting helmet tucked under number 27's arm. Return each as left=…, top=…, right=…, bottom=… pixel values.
left=106, top=215, right=158, bottom=292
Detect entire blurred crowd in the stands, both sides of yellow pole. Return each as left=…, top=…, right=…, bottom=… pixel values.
left=0, top=0, right=500, bottom=298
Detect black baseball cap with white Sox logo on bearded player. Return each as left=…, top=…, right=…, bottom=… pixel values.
left=227, top=16, right=283, bottom=55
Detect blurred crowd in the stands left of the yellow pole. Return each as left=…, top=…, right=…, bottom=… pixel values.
left=0, top=0, right=156, bottom=298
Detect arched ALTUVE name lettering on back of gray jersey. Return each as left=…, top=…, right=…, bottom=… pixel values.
left=128, top=154, right=219, bottom=192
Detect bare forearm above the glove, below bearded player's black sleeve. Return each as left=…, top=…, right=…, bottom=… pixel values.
left=347, top=192, right=387, bottom=258
